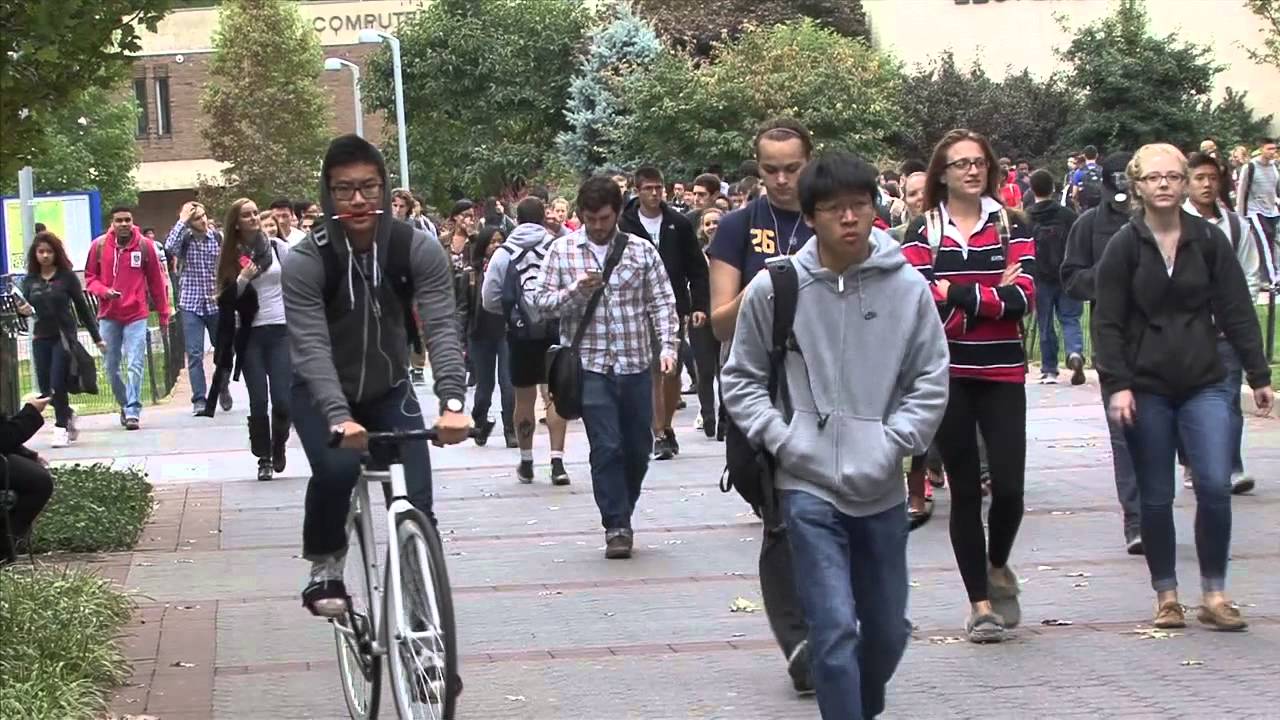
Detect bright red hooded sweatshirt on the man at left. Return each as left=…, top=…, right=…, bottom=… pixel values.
left=84, top=227, right=172, bottom=325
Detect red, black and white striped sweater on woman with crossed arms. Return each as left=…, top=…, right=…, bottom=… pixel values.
left=902, top=197, right=1036, bottom=383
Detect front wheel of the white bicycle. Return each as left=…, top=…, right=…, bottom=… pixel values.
left=385, top=510, right=461, bottom=720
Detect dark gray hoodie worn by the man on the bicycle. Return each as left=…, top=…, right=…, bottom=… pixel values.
left=282, top=136, right=466, bottom=425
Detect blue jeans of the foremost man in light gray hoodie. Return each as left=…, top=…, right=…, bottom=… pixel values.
left=782, top=491, right=911, bottom=720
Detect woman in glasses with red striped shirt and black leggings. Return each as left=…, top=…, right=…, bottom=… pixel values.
left=902, top=129, right=1036, bottom=643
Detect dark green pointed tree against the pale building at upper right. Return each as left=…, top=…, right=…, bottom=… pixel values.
left=1061, top=0, right=1222, bottom=151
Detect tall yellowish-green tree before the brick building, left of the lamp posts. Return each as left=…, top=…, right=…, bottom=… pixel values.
left=200, top=0, right=333, bottom=206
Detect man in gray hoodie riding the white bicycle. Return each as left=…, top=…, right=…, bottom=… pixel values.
left=282, top=135, right=471, bottom=618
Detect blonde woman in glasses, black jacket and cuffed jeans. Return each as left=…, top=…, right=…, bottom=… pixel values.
left=1093, top=143, right=1275, bottom=630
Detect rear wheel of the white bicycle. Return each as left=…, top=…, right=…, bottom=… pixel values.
left=332, top=497, right=383, bottom=720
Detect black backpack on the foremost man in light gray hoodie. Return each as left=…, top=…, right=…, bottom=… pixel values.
left=721, top=255, right=800, bottom=509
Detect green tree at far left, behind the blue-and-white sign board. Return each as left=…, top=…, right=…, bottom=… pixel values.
left=0, top=87, right=138, bottom=210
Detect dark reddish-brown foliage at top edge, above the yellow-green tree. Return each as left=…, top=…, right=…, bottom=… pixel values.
left=635, top=0, right=870, bottom=56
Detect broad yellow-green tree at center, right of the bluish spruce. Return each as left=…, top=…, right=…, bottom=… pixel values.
left=612, top=20, right=904, bottom=176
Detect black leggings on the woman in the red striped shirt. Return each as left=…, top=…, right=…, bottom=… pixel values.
left=936, top=378, right=1027, bottom=602
